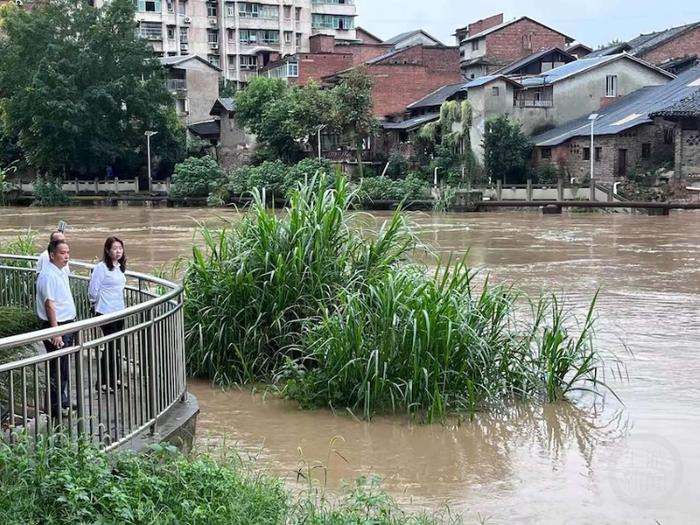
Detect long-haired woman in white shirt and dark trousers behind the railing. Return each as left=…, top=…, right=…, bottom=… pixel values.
left=88, top=237, right=126, bottom=392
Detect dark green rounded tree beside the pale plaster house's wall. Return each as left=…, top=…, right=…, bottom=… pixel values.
left=483, top=115, right=532, bottom=184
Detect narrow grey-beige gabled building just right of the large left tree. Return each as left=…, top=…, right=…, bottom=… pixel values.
left=160, top=55, right=221, bottom=126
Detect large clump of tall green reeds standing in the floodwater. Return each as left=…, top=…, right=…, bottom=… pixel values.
left=185, top=177, right=616, bottom=420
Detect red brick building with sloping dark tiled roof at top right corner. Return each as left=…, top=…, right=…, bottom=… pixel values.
left=589, top=21, right=700, bottom=74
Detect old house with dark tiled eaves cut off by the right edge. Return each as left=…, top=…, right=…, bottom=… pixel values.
left=650, top=87, right=700, bottom=180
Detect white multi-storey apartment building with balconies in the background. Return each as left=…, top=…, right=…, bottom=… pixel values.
left=95, top=0, right=357, bottom=83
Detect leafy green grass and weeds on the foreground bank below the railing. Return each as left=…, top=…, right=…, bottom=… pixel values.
left=0, top=436, right=456, bottom=525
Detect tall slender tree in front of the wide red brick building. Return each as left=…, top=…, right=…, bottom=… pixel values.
left=331, top=68, right=379, bottom=177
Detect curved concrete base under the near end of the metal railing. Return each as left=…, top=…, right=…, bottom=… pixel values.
left=117, top=392, right=199, bottom=454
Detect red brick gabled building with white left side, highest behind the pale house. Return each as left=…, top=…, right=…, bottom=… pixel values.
left=455, top=13, right=574, bottom=79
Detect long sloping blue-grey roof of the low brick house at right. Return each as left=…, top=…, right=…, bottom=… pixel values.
left=532, top=68, right=700, bottom=147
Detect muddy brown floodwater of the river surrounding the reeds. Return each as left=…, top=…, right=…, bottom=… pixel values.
left=0, top=207, right=700, bottom=525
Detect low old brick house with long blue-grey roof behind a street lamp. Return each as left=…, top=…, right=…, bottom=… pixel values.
left=532, top=69, right=700, bottom=182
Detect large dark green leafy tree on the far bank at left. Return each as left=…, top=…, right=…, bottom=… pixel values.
left=0, top=0, right=184, bottom=175
